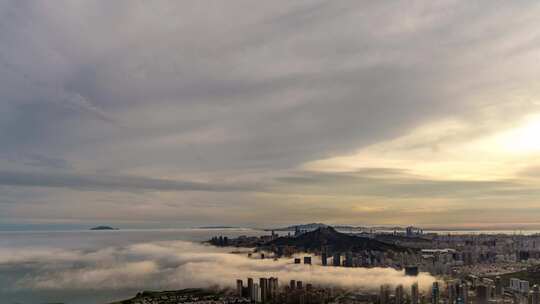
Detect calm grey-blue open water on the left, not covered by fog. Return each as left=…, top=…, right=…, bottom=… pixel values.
left=0, top=229, right=266, bottom=304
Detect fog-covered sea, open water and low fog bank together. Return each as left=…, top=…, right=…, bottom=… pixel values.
left=0, top=229, right=498, bottom=304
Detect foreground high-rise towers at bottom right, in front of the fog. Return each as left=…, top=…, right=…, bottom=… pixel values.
left=235, top=276, right=540, bottom=304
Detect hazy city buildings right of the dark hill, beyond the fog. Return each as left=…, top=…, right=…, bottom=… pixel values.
left=294, top=232, right=540, bottom=276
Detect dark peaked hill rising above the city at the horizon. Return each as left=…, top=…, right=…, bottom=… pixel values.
left=265, top=225, right=411, bottom=252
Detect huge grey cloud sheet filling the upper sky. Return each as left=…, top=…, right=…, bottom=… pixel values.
left=1, top=1, right=535, bottom=171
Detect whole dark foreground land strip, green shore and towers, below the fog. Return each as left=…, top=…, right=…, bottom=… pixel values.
left=118, top=276, right=540, bottom=304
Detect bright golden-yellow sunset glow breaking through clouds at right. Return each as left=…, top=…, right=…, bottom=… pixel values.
left=304, top=115, right=540, bottom=180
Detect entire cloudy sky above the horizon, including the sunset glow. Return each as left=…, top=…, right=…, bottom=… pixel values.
left=0, top=0, right=540, bottom=228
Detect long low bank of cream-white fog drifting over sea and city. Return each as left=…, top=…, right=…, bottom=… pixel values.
left=0, top=241, right=434, bottom=290
